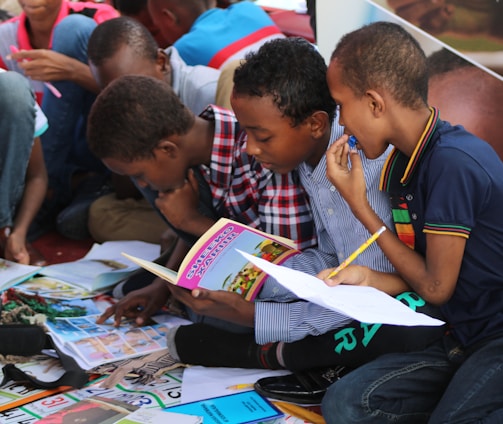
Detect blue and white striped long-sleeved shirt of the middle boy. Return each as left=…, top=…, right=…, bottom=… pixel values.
left=255, top=119, right=394, bottom=344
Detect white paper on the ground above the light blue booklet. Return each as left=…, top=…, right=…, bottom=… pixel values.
left=181, top=365, right=292, bottom=403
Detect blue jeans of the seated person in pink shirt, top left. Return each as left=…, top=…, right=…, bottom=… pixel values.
left=41, top=14, right=105, bottom=207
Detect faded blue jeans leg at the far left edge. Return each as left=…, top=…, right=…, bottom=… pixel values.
left=0, top=72, right=35, bottom=228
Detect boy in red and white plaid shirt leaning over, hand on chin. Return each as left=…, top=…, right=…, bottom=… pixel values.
left=88, top=75, right=315, bottom=327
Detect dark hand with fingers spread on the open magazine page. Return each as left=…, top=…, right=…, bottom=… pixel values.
left=96, top=278, right=169, bottom=327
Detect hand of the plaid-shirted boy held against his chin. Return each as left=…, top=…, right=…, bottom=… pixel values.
left=155, top=169, right=201, bottom=232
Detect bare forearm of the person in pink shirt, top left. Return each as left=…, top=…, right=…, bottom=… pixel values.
left=11, top=49, right=100, bottom=94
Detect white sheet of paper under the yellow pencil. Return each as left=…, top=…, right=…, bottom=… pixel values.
left=239, top=251, right=444, bottom=326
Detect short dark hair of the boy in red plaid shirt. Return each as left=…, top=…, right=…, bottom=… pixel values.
left=87, top=75, right=195, bottom=162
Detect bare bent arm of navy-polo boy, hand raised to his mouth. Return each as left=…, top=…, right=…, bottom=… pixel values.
left=327, top=136, right=466, bottom=305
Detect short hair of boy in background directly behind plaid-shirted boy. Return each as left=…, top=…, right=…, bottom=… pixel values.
left=87, top=16, right=158, bottom=66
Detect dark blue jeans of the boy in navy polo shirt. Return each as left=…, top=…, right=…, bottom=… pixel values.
left=322, top=335, right=503, bottom=424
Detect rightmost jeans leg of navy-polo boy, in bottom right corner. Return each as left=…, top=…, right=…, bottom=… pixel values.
left=431, top=337, right=503, bottom=423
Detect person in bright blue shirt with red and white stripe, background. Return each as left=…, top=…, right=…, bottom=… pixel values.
left=148, top=0, right=284, bottom=69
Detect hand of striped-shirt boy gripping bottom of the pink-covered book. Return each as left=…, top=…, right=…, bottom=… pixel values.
left=169, top=285, right=255, bottom=327
